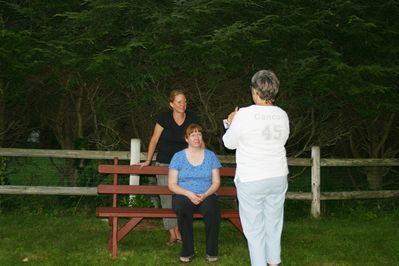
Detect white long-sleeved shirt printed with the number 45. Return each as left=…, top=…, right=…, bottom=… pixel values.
left=223, top=105, right=290, bottom=182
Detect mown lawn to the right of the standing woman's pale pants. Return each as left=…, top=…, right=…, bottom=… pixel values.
left=283, top=218, right=399, bottom=266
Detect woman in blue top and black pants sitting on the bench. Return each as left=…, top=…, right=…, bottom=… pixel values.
left=168, top=124, right=221, bottom=262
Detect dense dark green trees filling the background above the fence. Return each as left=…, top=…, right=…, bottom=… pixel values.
left=0, top=0, right=399, bottom=186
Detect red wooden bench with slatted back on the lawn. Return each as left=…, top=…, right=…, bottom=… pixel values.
left=96, top=158, right=242, bottom=258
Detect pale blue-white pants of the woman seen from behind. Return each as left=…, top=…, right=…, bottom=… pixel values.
left=235, top=176, right=288, bottom=266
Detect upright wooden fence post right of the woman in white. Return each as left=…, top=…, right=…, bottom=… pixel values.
left=310, top=146, right=320, bottom=218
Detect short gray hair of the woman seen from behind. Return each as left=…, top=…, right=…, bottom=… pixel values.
left=251, top=70, right=280, bottom=102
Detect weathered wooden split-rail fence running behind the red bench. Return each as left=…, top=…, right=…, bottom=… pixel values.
left=0, top=147, right=399, bottom=217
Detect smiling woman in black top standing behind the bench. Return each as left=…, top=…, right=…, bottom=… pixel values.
left=141, top=90, right=198, bottom=245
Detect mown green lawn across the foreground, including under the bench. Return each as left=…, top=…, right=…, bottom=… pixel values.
left=0, top=213, right=399, bottom=266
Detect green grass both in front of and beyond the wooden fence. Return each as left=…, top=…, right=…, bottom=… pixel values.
left=0, top=158, right=399, bottom=266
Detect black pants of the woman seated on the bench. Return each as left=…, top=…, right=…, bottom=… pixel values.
left=172, top=194, right=220, bottom=257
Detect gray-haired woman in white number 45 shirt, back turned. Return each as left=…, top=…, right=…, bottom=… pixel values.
left=223, top=70, right=289, bottom=266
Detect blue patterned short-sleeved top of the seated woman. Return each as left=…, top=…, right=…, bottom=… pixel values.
left=169, top=149, right=222, bottom=194
